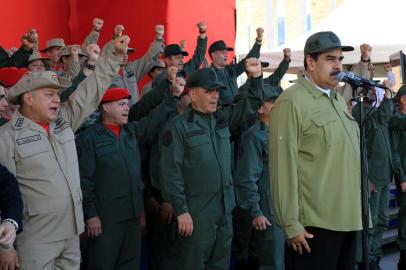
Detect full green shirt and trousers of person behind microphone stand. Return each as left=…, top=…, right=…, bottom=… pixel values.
left=352, top=98, right=393, bottom=264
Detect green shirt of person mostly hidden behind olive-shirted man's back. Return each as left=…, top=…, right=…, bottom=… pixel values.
left=235, top=120, right=273, bottom=218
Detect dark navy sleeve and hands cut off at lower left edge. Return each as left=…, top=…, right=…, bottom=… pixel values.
left=0, top=164, right=23, bottom=270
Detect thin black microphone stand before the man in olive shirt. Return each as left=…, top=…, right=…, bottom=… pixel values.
left=349, top=82, right=369, bottom=270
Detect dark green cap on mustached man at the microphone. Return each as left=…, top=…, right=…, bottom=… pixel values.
left=304, top=31, right=354, bottom=55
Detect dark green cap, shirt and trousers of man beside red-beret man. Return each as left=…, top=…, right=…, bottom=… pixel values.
left=161, top=68, right=262, bottom=270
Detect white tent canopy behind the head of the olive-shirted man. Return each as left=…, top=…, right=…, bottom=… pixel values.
left=246, top=0, right=406, bottom=73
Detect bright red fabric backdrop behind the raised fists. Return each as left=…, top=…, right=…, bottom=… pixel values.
left=0, top=0, right=236, bottom=86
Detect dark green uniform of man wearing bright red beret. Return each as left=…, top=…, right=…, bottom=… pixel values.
left=77, top=94, right=177, bottom=269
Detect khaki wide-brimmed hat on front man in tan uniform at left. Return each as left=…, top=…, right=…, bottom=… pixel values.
left=8, top=71, right=71, bottom=105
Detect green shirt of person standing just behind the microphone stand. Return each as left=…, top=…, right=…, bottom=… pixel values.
left=352, top=98, right=393, bottom=184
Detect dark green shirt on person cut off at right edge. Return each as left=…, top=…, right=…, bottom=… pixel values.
left=389, top=112, right=406, bottom=183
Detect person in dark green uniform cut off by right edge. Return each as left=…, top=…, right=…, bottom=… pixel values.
left=388, top=85, right=406, bottom=270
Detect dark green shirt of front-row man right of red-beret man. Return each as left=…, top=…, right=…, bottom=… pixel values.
left=161, top=77, right=263, bottom=217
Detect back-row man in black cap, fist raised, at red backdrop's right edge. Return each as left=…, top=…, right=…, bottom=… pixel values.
left=209, top=28, right=264, bottom=106
